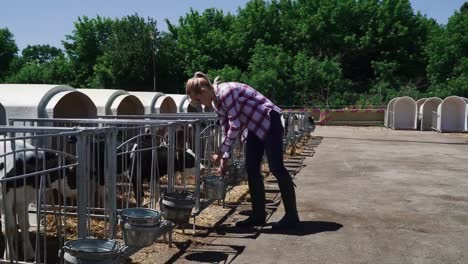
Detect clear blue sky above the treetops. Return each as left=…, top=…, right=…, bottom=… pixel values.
left=0, top=0, right=465, bottom=50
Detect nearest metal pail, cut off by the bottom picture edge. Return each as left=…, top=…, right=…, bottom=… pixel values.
left=62, top=238, right=121, bottom=264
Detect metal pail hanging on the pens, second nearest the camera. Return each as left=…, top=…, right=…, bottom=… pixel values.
left=120, top=208, right=161, bottom=248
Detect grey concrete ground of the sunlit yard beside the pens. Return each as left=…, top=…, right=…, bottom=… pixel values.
left=174, top=127, right=468, bottom=264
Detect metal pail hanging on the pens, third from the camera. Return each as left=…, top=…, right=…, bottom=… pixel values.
left=161, top=191, right=195, bottom=225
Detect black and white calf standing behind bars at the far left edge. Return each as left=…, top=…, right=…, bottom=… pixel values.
left=0, top=136, right=76, bottom=260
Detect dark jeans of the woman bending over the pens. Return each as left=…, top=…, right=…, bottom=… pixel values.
left=245, top=110, right=297, bottom=217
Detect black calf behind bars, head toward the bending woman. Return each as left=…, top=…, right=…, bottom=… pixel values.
left=130, top=136, right=204, bottom=207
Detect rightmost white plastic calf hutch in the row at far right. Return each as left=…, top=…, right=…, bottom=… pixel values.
left=436, top=96, right=466, bottom=132
